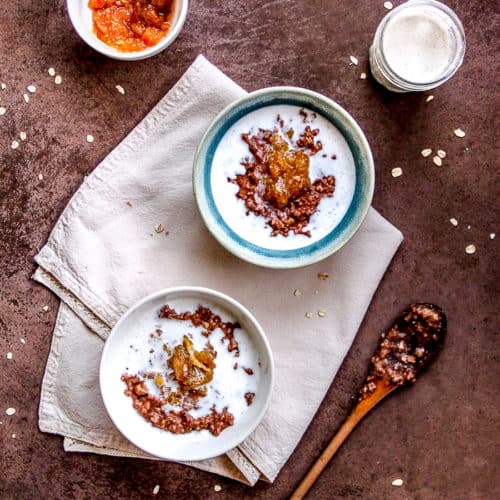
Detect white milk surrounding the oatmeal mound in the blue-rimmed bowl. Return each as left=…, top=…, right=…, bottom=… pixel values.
left=210, top=105, right=356, bottom=250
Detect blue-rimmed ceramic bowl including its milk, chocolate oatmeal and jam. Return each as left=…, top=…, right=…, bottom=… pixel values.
left=193, top=87, right=375, bottom=269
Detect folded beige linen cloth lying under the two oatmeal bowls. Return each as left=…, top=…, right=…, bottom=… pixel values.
left=34, top=56, right=402, bottom=485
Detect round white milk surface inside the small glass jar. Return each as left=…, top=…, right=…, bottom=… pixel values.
left=382, top=7, right=457, bottom=83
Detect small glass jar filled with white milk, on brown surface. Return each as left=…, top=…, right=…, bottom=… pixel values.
left=370, top=0, right=465, bottom=92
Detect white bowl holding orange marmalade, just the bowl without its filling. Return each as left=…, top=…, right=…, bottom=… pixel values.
left=66, top=0, right=189, bottom=61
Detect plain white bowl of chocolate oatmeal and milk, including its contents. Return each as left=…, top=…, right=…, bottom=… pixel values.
left=99, top=287, right=274, bottom=461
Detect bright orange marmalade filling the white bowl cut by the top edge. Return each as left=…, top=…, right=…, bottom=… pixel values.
left=89, top=0, right=175, bottom=52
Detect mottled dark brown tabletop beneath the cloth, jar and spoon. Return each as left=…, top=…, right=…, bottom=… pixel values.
left=0, top=0, right=500, bottom=499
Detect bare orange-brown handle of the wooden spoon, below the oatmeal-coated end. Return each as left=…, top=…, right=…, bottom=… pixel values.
left=290, top=386, right=395, bottom=500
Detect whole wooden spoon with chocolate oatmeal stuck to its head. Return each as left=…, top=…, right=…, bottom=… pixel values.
left=291, top=304, right=446, bottom=500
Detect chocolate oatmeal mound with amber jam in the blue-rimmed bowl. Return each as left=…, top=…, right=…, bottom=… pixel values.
left=228, top=115, right=335, bottom=237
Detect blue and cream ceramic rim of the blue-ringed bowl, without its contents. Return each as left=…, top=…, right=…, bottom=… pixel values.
left=193, top=87, right=374, bottom=268
